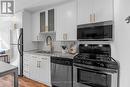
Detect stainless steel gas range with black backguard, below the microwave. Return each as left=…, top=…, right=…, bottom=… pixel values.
left=73, top=44, right=119, bottom=87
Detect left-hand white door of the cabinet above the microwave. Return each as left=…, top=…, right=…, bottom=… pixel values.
left=77, top=0, right=92, bottom=25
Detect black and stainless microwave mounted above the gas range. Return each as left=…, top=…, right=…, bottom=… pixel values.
left=77, top=21, right=113, bottom=41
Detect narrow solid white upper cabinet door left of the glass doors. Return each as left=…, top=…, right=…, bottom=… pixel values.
left=32, top=12, right=40, bottom=41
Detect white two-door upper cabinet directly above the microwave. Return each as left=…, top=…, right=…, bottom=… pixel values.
left=77, top=0, right=113, bottom=25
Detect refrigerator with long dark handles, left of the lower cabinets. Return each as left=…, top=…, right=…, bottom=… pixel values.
left=10, top=28, right=23, bottom=76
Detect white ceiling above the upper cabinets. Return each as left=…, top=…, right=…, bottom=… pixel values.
left=15, top=0, right=71, bottom=12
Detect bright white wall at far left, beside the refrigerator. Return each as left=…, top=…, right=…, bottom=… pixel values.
left=0, top=17, right=12, bottom=49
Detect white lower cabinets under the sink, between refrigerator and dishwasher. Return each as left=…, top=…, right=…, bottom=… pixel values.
left=23, top=54, right=51, bottom=86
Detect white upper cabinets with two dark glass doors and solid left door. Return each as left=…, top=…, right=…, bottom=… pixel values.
left=32, top=9, right=55, bottom=41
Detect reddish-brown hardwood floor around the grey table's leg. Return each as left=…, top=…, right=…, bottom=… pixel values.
left=0, top=75, right=47, bottom=87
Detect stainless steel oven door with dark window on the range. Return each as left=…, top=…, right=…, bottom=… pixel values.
left=73, top=65, right=117, bottom=87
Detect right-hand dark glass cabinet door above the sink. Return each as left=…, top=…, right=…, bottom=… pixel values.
left=48, top=9, right=54, bottom=31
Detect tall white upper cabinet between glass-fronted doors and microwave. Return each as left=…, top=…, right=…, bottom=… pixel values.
left=56, top=1, right=77, bottom=41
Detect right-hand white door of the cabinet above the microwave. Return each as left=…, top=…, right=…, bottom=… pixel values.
left=93, top=0, right=113, bottom=22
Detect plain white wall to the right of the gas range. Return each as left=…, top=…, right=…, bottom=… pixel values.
left=114, top=0, right=130, bottom=87
